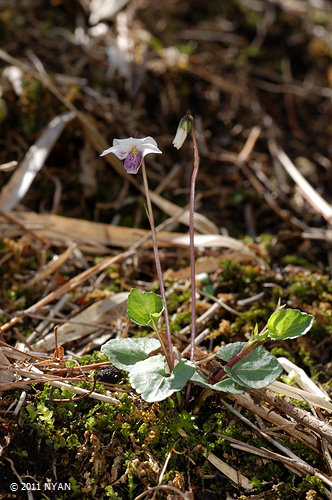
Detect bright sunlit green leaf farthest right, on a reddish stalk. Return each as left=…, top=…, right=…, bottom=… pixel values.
left=267, top=309, right=314, bottom=340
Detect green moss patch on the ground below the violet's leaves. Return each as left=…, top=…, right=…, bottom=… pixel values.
left=16, top=370, right=320, bottom=499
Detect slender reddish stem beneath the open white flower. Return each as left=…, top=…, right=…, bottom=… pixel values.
left=142, top=158, right=174, bottom=371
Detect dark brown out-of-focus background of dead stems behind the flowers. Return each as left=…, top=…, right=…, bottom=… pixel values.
left=0, top=0, right=332, bottom=263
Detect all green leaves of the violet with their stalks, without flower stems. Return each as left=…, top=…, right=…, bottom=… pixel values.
left=102, top=289, right=313, bottom=402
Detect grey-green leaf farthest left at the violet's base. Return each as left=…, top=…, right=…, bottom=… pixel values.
left=101, top=338, right=160, bottom=371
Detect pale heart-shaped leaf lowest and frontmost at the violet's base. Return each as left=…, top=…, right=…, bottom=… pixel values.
left=129, top=354, right=195, bottom=403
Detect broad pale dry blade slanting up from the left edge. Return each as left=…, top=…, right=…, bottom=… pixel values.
left=0, top=111, right=75, bottom=210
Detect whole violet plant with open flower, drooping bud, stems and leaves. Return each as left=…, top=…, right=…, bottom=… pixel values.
left=101, top=119, right=314, bottom=408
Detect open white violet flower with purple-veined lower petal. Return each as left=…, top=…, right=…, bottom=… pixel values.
left=100, top=136, right=162, bottom=174
